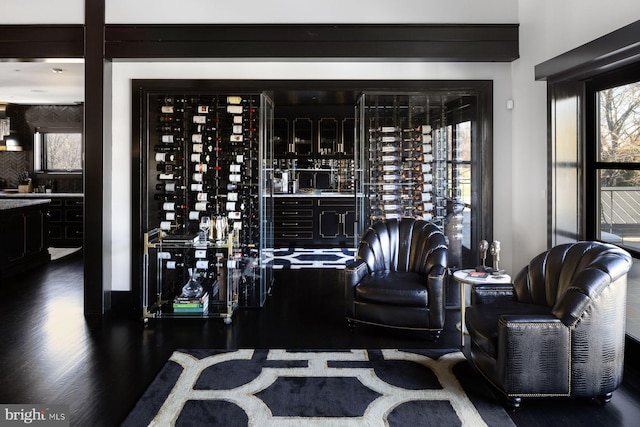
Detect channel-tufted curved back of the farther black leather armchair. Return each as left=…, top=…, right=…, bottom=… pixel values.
left=358, top=218, right=447, bottom=276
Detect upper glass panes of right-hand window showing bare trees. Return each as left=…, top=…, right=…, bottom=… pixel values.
left=594, top=82, right=640, bottom=250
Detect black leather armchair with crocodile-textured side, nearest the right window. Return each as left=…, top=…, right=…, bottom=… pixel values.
left=465, top=242, right=631, bottom=408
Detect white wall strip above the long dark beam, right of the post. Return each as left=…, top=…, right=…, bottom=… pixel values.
left=105, top=0, right=518, bottom=24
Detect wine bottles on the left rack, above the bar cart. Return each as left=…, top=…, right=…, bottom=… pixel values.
left=154, top=96, right=259, bottom=247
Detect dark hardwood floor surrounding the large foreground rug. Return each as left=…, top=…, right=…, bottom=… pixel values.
left=0, top=254, right=640, bottom=427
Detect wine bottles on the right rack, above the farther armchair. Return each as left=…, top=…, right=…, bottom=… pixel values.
left=369, top=125, right=447, bottom=227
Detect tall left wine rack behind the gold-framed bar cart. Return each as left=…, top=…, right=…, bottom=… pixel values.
left=142, top=93, right=272, bottom=320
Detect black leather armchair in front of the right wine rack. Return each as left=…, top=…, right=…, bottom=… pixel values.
left=345, top=218, right=447, bottom=339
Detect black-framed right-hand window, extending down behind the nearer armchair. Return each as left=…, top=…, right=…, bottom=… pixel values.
left=585, top=65, right=640, bottom=341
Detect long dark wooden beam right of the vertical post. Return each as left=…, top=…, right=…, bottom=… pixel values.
left=105, top=24, right=519, bottom=62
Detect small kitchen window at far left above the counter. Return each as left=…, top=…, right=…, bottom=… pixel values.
left=34, top=131, right=82, bottom=173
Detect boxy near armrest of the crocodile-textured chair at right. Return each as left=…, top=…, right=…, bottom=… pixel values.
left=498, top=315, right=571, bottom=395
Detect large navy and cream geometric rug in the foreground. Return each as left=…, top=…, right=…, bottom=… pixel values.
left=122, top=349, right=514, bottom=427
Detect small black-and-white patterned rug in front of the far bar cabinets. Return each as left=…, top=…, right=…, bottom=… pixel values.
left=264, top=248, right=356, bottom=270
